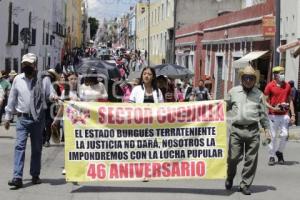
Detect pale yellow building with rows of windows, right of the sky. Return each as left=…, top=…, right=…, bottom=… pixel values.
left=136, top=0, right=174, bottom=65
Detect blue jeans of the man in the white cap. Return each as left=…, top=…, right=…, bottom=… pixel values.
left=14, top=116, right=44, bottom=178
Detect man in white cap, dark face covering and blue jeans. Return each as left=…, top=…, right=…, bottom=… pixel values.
left=5, top=53, right=56, bottom=189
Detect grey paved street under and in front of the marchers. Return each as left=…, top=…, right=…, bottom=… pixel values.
left=0, top=126, right=300, bottom=200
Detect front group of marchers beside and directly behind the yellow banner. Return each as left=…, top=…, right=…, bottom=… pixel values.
left=0, top=51, right=297, bottom=195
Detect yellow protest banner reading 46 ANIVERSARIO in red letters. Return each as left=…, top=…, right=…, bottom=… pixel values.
left=64, top=101, right=227, bottom=182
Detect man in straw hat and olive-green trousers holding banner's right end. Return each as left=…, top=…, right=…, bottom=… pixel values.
left=225, top=65, right=270, bottom=195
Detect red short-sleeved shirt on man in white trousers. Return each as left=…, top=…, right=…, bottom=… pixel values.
left=264, top=81, right=291, bottom=115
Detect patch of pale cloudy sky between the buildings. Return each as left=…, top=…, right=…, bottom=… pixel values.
left=88, top=0, right=138, bottom=19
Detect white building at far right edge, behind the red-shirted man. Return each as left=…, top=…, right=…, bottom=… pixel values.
left=280, top=0, right=300, bottom=89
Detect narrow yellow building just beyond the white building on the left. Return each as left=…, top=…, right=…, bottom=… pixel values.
left=66, top=0, right=83, bottom=50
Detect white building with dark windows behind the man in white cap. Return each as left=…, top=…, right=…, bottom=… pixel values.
left=0, top=0, right=66, bottom=72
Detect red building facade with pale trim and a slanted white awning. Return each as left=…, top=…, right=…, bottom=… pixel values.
left=176, top=0, right=275, bottom=99
